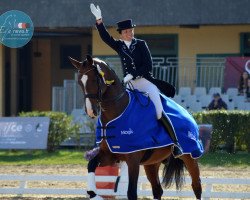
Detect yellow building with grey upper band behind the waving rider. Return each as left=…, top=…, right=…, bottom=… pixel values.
left=0, top=0, right=250, bottom=116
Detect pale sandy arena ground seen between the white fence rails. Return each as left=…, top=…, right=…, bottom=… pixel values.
left=0, top=165, right=250, bottom=200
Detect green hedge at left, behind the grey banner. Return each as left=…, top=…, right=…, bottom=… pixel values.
left=19, top=111, right=80, bottom=152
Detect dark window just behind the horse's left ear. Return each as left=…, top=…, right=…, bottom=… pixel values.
left=60, top=45, right=82, bottom=69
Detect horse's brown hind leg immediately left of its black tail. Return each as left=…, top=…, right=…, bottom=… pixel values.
left=144, top=163, right=163, bottom=200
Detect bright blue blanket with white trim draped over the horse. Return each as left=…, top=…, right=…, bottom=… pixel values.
left=96, top=91, right=203, bottom=158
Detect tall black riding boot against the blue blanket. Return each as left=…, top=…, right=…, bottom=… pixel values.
left=159, top=112, right=183, bottom=158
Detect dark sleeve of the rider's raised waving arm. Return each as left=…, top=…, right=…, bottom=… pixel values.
left=96, top=19, right=118, bottom=51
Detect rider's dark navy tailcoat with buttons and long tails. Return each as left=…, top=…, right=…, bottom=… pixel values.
left=96, top=23, right=175, bottom=97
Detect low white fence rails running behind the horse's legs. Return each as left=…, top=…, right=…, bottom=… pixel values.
left=0, top=175, right=250, bottom=200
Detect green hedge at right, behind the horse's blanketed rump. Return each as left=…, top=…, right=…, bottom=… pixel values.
left=193, top=110, right=250, bottom=153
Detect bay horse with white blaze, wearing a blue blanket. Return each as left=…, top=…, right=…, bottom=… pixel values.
left=69, top=55, right=202, bottom=200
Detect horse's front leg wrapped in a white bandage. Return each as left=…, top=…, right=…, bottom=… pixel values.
left=87, top=155, right=103, bottom=200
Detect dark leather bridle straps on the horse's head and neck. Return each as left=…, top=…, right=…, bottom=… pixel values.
left=78, top=64, right=126, bottom=104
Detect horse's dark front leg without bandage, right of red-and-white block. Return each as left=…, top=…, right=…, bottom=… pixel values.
left=127, top=161, right=140, bottom=200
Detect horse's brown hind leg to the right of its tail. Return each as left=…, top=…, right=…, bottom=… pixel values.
left=181, top=155, right=202, bottom=199
